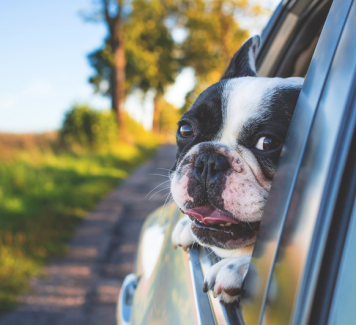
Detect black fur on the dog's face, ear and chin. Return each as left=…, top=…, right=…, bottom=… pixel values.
left=172, top=37, right=300, bottom=249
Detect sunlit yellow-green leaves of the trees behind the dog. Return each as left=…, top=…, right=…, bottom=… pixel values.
left=88, top=0, right=268, bottom=125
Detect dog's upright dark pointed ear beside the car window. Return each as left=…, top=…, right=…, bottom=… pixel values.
left=221, top=35, right=260, bottom=80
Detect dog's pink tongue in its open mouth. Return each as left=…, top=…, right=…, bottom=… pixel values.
left=185, top=204, right=239, bottom=225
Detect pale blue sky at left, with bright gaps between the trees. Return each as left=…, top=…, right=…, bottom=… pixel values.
left=0, top=0, right=278, bottom=133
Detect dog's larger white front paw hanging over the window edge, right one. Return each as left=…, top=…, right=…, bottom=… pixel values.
left=203, top=256, right=251, bottom=303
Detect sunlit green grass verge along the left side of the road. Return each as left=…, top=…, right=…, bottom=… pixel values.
left=0, top=145, right=154, bottom=311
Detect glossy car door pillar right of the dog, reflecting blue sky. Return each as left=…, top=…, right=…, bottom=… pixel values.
left=241, top=0, right=356, bottom=324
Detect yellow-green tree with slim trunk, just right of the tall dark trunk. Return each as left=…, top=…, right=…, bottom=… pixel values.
left=126, top=0, right=180, bottom=133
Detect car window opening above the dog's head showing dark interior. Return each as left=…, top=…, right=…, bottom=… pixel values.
left=256, top=0, right=332, bottom=78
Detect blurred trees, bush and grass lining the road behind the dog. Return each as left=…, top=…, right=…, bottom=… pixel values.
left=0, top=0, right=268, bottom=312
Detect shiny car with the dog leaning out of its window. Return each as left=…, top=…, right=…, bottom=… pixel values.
left=118, top=0, right=356, bottom=325
